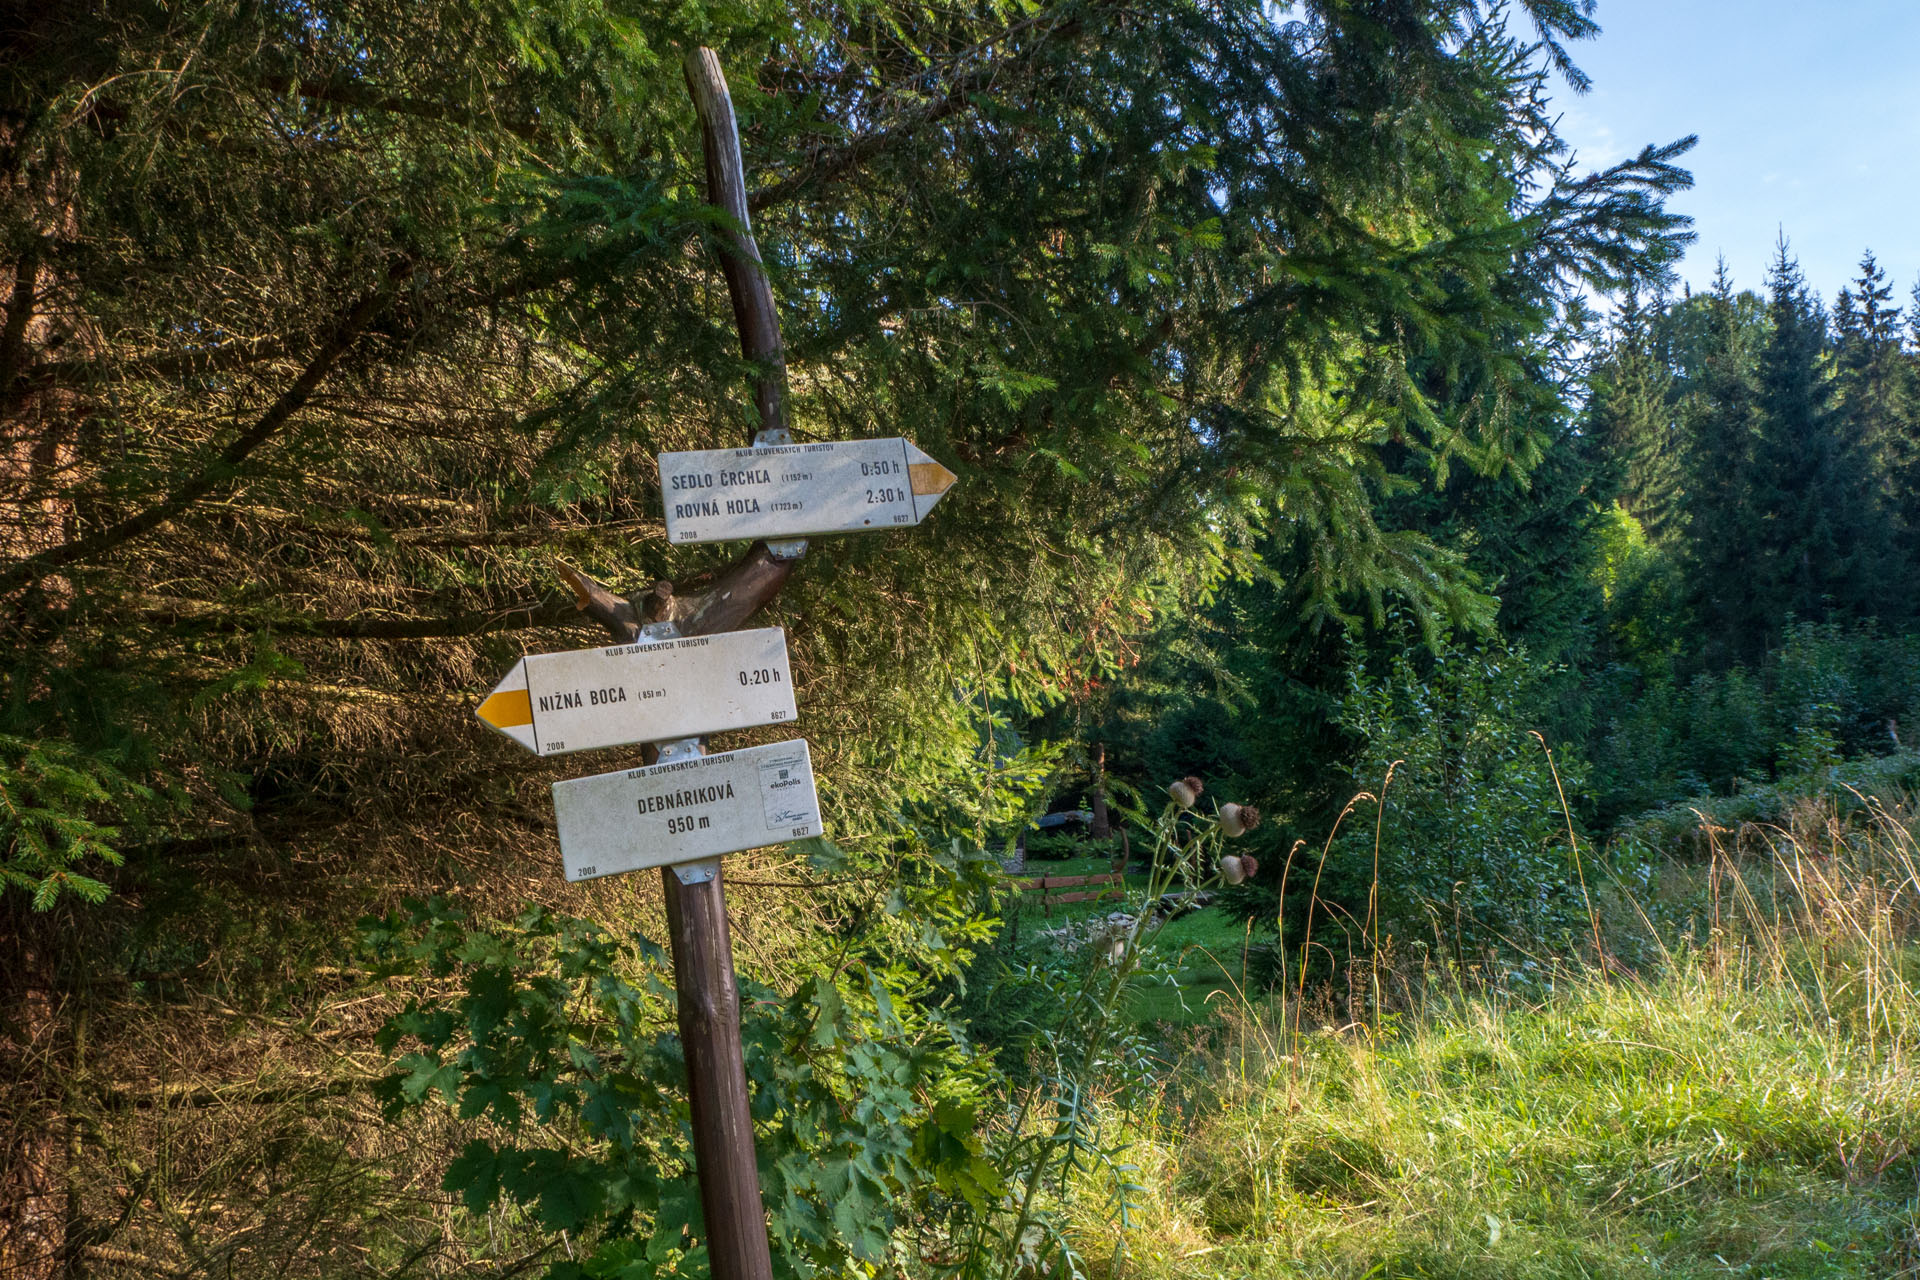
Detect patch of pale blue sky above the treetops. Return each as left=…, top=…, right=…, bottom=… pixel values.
left=1555, top=0, right=1920, bottom=305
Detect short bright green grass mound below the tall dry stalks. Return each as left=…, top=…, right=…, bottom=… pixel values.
left=1091, top=963, right=1920, bottom=1280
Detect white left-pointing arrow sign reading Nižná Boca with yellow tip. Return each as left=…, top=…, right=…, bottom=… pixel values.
left=474, top=628, right=795, bottom=756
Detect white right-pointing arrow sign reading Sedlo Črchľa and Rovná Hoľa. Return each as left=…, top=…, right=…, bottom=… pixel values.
left=660, top=438, right=954, bottom=543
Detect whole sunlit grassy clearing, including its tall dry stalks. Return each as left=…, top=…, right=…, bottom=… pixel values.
left=1081, top=814, right=1920, bottom=1280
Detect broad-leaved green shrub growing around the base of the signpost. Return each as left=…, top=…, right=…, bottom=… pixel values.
left=363, top=825, right=1004, bottom=1280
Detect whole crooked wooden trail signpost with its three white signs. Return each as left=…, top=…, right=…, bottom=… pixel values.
left=476, top=48, right=954, bottom=1280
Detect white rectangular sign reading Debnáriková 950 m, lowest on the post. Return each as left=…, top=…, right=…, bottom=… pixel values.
left=553, top=741, right=820, bottom=881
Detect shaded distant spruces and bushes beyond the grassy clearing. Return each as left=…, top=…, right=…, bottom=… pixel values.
left=1082, top=240, right=1920, bottom=951
